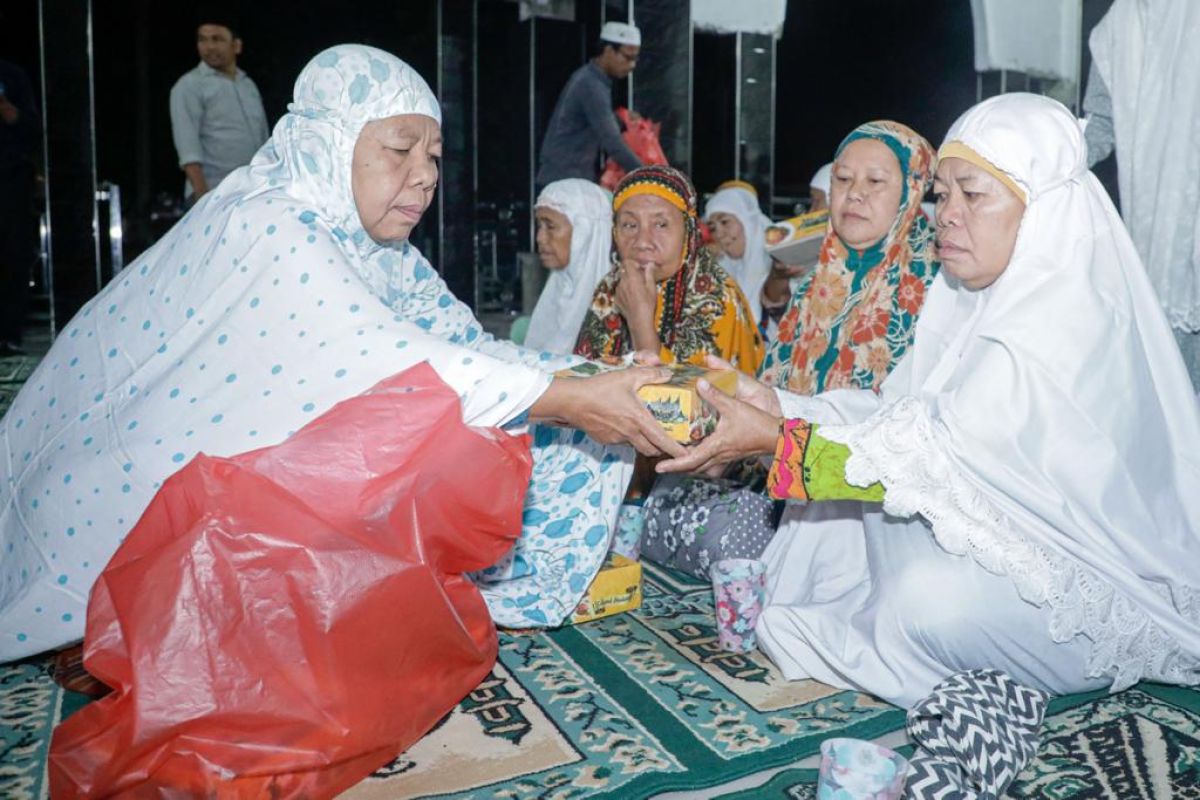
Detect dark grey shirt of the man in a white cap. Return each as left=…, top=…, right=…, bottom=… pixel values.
left=536, top=61, right=642, bottom=186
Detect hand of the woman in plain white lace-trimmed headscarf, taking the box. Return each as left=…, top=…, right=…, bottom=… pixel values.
left=655, top=378, right=782, bottom=476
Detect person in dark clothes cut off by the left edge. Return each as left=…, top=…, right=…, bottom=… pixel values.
left=0, top=60, right=42, bottom=357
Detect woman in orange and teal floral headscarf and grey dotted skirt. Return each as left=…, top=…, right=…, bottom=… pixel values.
left=642, top=121, right=938, bottom=577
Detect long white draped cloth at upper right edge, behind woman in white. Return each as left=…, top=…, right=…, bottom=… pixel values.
left=1090, top=0, right=1200, bottom=332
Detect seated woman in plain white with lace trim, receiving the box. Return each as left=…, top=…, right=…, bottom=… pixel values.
left=664, top=94, right=1200, bottom=706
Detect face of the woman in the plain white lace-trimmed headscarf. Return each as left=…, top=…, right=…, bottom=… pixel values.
left=934, top=158, right=1025, bottom=289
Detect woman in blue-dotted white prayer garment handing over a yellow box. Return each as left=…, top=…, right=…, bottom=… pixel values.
left=0, top=44, right=679, bottom=661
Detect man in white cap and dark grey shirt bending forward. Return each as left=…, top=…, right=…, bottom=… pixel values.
left=536, top=23, right=642, bottom=187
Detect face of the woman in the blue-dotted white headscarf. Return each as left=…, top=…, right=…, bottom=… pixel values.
left=350, top=114, right=442, bottom=242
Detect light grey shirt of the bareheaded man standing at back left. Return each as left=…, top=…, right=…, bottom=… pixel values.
left=170, top=61, right=270, bottom=196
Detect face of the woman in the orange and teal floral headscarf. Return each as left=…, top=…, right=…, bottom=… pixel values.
left=829, top=139, right=904, bottom=249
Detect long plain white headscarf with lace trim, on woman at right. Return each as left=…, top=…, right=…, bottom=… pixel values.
left=822, top=94, right=1200, bottom=690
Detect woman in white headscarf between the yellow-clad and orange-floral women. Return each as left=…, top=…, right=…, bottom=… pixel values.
left=704, top=181, right=770, bottom=324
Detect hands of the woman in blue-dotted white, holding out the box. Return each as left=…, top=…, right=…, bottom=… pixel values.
left=530, top=367, right=688, bottom=457
